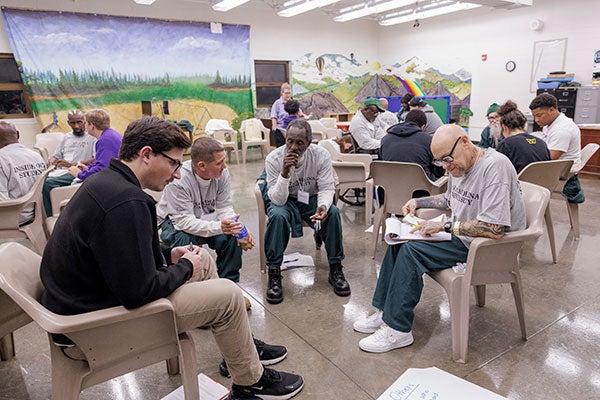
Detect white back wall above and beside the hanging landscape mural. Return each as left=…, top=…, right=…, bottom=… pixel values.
left=0, top=0, right=378, bottom=145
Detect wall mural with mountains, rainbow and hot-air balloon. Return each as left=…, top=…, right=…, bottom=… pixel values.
left=274, top=53, right=472, bottom=127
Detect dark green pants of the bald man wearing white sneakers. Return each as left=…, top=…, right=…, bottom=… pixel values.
left=373, top=236, right=469, bottom=332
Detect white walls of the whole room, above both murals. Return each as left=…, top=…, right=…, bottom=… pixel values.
left=0, top=0, right=600, bottom=144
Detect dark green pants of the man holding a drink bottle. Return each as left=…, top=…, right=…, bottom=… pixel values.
left=160, top=220, right=242, bottom=282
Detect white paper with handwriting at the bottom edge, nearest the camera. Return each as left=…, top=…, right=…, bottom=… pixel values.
left=377, top=367, right=507, bottom=400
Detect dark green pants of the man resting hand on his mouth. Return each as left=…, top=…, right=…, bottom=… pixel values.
left=264, top=196, right=344, bottom=270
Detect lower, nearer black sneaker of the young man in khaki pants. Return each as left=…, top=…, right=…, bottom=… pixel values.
left=228, top=368, right=304, bottom=400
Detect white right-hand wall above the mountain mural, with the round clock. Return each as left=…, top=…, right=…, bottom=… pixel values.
left=378, top=0, right=600, bottom=139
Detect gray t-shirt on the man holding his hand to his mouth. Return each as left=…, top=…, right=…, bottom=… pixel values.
left=265, top=144, right=335, bottom=210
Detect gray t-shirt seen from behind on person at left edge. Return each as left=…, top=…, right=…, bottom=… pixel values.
left=0, top=143, right=46, bottom=225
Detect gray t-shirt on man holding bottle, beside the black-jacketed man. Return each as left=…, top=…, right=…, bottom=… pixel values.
left=156, top=160, right=235, bottom=237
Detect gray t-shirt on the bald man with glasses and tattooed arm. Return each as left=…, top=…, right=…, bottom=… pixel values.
left=445, top=148, right=527, bottom=246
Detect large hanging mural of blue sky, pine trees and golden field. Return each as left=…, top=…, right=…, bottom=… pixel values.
left=3, top=9, right=252, bottom=132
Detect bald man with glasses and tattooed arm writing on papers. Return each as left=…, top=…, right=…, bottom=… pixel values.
left=354, top=125, right=526, bottom=353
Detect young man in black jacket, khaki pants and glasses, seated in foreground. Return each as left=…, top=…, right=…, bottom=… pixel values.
left=40, top=117, right=304, bottom=399
